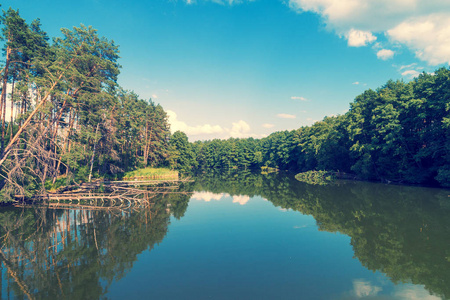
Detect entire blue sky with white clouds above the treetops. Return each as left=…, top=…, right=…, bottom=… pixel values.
left=1, top=0, right=450, bottom=141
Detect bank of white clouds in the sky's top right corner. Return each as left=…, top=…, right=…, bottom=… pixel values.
left=289, top=0, right=450, bottom=65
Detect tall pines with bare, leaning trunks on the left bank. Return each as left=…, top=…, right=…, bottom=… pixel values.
left=0, top=8, right=170, bottom=200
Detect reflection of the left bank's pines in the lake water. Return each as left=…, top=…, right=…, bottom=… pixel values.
left=0, top=194, right=190, bottom=299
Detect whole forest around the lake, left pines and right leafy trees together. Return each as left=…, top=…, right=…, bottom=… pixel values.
left=0, top=8, right=450, bottom=202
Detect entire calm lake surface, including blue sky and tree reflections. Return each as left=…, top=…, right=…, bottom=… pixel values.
left=0, top=174, right=450, bottom=299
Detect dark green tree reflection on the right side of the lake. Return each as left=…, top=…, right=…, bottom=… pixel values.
left=194, top=174, right=450, bottom=299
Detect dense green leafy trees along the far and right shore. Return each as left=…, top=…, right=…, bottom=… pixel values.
left=174, top=68, right=450, bottom=186
